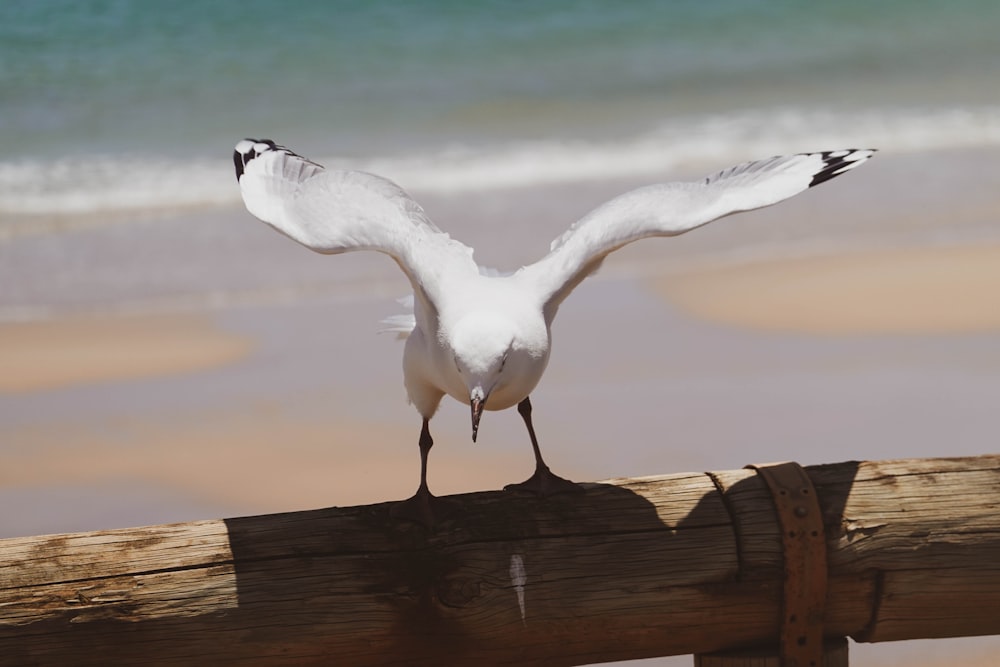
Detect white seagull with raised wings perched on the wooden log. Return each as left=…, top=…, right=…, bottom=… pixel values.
left=233, top=139, right=875, bottom=527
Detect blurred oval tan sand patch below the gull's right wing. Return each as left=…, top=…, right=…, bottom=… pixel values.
left=652, top=245, right=1000, bottom=336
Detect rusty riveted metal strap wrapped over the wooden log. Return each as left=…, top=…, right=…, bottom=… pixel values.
left=747, top=461, right=827, bottom=667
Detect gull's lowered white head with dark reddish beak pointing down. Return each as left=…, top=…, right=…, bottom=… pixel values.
left=450, top=313, right=521, bottom=442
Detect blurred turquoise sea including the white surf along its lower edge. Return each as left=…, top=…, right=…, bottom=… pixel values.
left=0, top=0, right=1000, bottom=224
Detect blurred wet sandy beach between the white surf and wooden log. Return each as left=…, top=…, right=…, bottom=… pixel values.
left=0, top=152, right=1000, bottom=666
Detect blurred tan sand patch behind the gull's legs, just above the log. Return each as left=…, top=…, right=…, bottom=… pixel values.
left=0, top=405, right=544, bottom=514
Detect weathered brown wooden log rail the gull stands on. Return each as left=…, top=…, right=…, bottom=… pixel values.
left=0, top=456, right=1000, bottom=665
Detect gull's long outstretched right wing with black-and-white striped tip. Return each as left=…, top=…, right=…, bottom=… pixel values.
left=521, top=149, right=875, bottom=322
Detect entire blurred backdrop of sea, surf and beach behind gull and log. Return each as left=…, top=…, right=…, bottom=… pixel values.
left=0, top=0, right=1000, bottom=665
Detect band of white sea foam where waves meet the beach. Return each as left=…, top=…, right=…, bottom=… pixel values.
left=0, top=107, right=1000, bottom=224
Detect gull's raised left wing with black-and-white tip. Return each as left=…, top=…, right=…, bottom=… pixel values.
left=233, top=139, right=478, bottom=316
